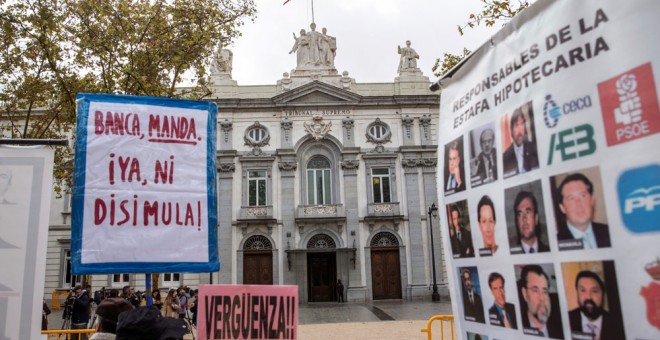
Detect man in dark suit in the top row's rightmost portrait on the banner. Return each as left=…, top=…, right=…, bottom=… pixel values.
left=502, top=102, right=539, bottom=178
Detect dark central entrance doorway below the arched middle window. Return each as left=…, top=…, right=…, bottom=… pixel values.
left=307, top=252, right=337, bottom=302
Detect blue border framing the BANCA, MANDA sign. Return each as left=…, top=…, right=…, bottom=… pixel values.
left=71, top=93, right=220, bottom=275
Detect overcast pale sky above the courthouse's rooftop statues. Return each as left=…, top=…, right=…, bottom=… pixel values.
left=229, top=0, right=500, bottom=85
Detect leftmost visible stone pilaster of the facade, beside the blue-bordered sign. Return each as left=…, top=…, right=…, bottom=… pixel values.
left=213, top=151, right=236, bottom=284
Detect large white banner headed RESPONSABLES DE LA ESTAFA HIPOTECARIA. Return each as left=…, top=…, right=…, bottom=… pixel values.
left=438, top=0, right=660, bottom=340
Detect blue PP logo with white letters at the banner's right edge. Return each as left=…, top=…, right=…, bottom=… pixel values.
left=617, top=164, right=660, bottom=233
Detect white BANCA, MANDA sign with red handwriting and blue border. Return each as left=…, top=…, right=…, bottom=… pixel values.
left=71, top=94, right=219, bottom=274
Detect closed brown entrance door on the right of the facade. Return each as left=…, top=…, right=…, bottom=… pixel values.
left=371, top=247, right=401, bottom=300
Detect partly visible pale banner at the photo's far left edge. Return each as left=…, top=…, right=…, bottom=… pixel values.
left=0, top=145, right=53, bottom=339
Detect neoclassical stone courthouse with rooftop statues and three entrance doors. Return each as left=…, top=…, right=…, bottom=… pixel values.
left=45, top=25, right=447, bottom=302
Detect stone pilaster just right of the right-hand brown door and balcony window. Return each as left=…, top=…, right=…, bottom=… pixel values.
left=401, top=154, right=427, bottom=298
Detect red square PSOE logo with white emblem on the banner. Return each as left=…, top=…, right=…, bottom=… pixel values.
left=598, top=63, right=660, bottom=146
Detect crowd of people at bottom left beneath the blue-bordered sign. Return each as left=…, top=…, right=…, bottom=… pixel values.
left=42, top=285, right=198, bottom=340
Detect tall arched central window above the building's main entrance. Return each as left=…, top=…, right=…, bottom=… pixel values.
left=307, top=156, right=332, bottom=205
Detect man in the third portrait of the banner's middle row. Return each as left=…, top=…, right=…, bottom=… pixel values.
left=513, top=190, right=550, bottom=254
